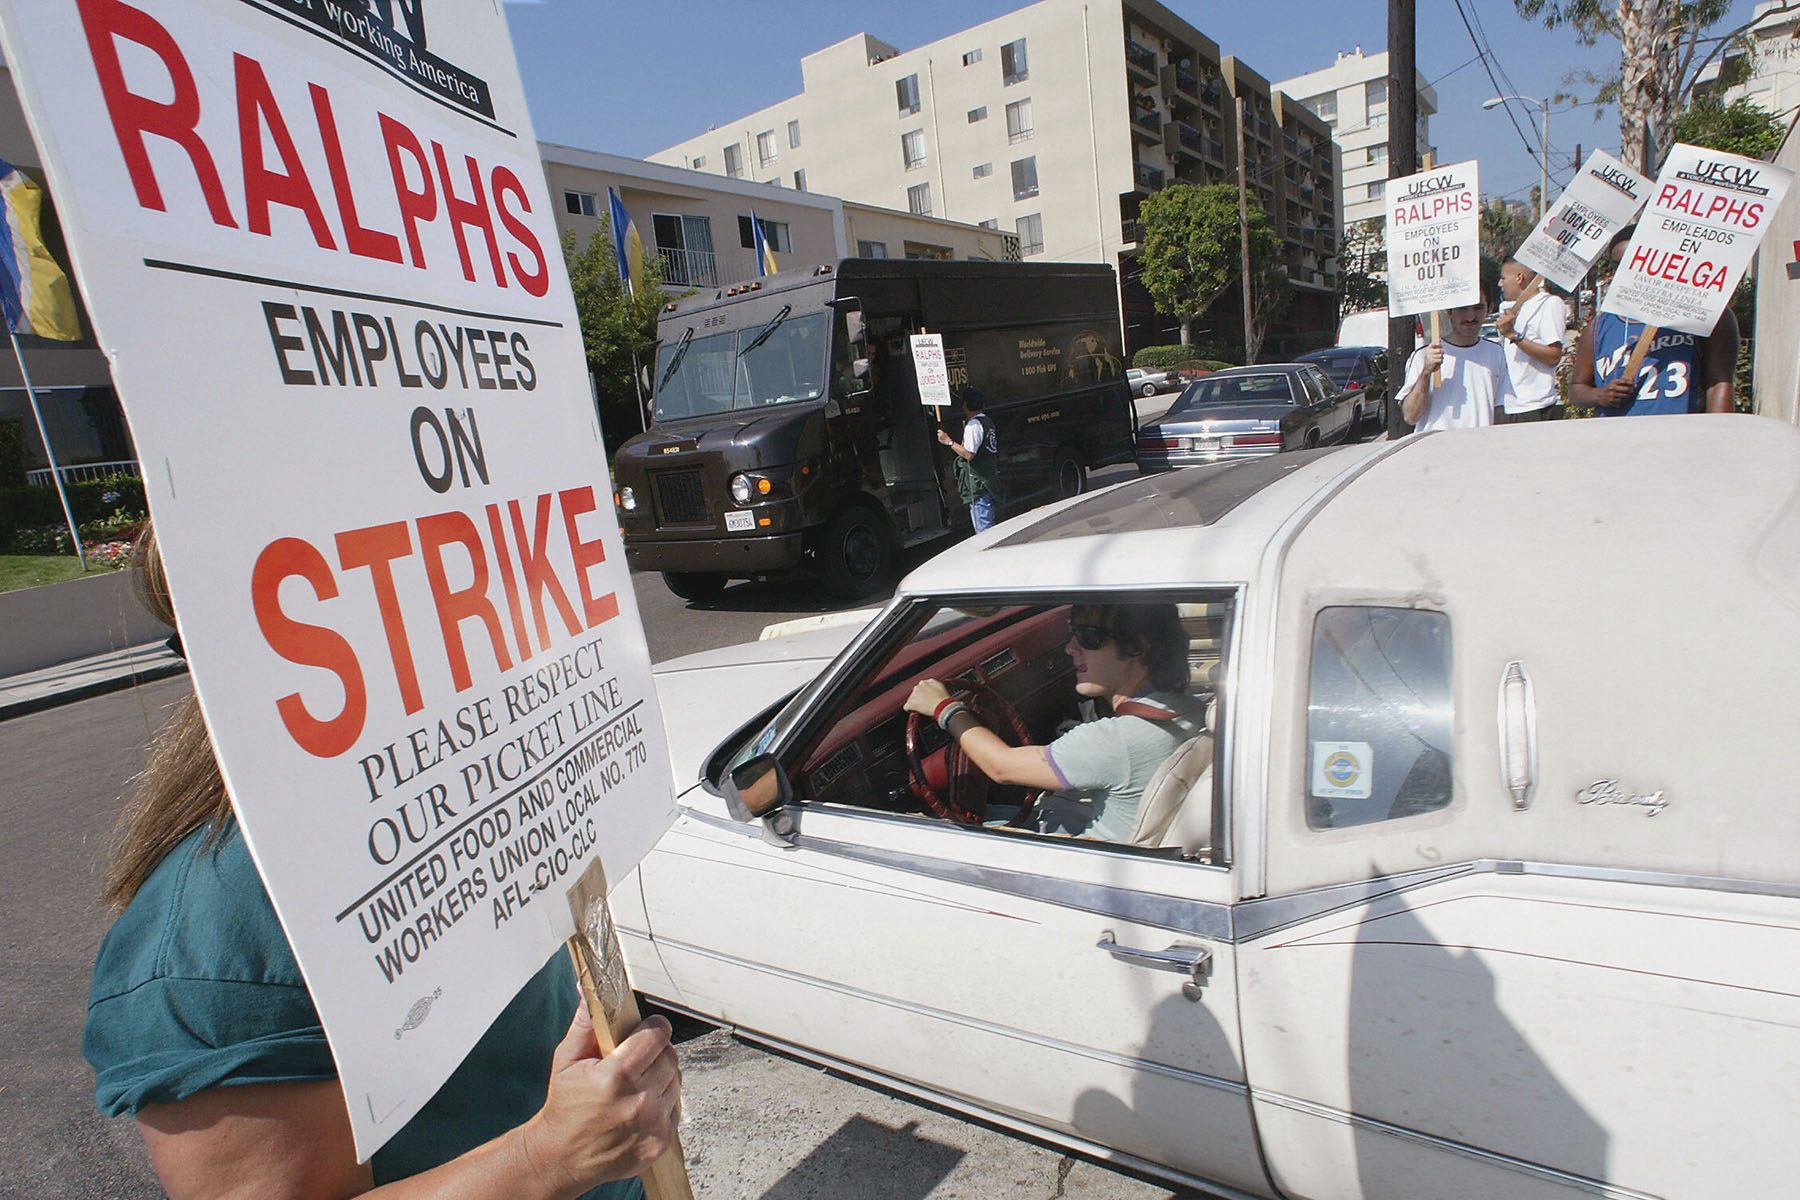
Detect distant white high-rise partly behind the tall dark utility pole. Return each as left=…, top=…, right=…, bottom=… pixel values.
left=1274, top=47, right=1438, bottom=228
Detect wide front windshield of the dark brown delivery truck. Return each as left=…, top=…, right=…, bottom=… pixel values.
left=653, top=313, right=828, bottom=421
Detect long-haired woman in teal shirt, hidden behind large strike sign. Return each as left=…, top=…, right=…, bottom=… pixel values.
left=83, top=536, right=680, bottom=1200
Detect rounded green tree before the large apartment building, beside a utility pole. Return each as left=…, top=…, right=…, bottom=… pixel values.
left=1138, top=184, right=1282, bottom=345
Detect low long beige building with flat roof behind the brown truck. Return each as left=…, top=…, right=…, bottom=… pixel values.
left=538, top=142, right=1019, bottom=291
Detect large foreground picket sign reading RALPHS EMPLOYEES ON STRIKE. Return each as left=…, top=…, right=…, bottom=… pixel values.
left=0, top=0, right=673, bottom=1159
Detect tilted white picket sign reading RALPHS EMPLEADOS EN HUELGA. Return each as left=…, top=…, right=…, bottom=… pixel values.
left=1600, top=144, right=1793, bottom=336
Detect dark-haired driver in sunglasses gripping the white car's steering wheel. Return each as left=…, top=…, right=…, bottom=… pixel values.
left=905, top=604, right=1206, bottom=842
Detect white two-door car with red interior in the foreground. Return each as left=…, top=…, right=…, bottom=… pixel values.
left=614, top=416, right=1800, bottom=1200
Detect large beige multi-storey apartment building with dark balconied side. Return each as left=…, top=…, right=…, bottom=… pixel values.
left=650, top=0, right=1337, bottom=345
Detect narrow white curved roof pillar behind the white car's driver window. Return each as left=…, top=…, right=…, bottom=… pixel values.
left=1228, top=434, right=1429, bottom=896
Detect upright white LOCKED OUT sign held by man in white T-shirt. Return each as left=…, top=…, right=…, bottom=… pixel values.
left=1386, top=160, right=1481, bottom=317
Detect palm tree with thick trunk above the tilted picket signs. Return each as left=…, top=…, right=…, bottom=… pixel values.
left=1512, top=0, right=1800, bottom=175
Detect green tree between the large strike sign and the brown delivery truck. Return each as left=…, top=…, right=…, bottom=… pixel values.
left=563, top=230, right=668, bottom=453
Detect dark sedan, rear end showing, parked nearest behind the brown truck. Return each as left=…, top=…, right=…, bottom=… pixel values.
left=1138, top=363, right=1359, bottom=471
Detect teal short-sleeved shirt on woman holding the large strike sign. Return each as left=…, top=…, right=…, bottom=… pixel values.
left=81, top=826, right=643, bottom=1200
